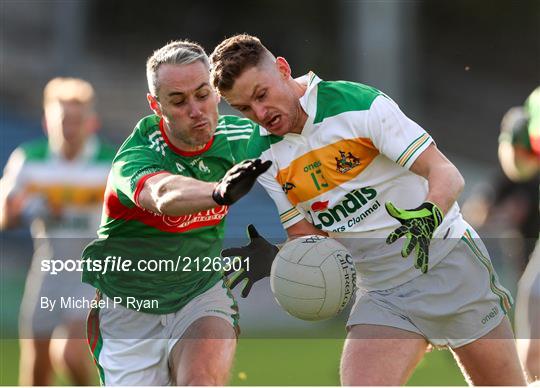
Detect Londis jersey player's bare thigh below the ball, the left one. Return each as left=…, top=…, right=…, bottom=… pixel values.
left=341, top=324, right=428, bottom=385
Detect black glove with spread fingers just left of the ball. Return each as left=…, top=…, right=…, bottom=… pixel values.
left=221, top=224, right=279, bottom=298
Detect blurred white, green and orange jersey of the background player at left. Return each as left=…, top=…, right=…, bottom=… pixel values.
left=3, top=136, right=115, bottom=239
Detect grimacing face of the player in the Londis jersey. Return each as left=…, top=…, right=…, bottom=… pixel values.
left=222, top=58, right=303, bottom=136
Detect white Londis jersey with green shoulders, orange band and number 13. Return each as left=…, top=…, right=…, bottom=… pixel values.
left=248, top=73, right=466, bottom=290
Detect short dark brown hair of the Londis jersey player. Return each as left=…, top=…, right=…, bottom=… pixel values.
left=210, top=34, right=273, bottom=92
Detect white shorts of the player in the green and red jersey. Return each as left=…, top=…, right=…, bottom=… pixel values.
left=87, top=281, right=238, bottom=386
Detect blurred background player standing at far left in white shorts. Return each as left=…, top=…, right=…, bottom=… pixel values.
left=0, top=78, right=114, bottom=385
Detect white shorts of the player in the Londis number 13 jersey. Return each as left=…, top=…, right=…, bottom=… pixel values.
left=347, top=229, right=512, bottom=348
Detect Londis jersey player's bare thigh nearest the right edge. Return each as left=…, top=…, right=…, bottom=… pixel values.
left=453, top=317, right=526, bottom=385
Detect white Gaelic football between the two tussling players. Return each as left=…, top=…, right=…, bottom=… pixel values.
left=270, top=235, right=356, bottom=321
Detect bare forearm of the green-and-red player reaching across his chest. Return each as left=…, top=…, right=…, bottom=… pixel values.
left=139, top=175, right=218, bottom=216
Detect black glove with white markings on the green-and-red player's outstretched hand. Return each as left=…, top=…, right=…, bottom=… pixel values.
left=212, top=159, right=272, bottom=205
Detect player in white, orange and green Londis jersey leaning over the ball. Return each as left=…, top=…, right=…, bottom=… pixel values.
left=211, top=34, right=525, bottom=385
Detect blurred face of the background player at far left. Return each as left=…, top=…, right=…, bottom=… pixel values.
left=45, top=101, right=97, bottom=152
